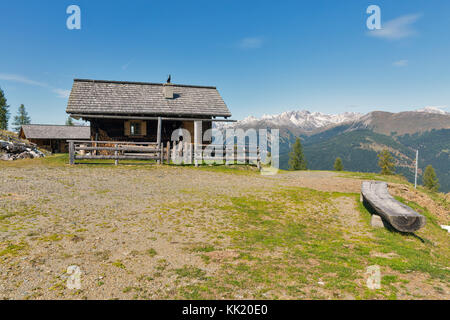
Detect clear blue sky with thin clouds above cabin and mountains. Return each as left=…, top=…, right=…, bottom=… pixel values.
left=0, top=0, right=450, bottom=123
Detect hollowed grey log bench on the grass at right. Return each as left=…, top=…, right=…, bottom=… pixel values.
left=361, top=181, right=426, bottom=232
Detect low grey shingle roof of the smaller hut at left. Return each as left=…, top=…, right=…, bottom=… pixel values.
left=22, top=124, right=91, bottom=139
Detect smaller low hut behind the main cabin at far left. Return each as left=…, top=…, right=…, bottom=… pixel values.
left=19, top=124, right=91, bottom=153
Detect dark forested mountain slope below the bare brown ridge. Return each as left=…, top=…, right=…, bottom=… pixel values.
left=280, top=126, right=450, bottom=192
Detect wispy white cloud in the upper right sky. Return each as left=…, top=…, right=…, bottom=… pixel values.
left=368, top=14, right=421, bottom=40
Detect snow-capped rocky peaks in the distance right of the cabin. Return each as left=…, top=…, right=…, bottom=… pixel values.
left=224, top=110, right=363, bottom=133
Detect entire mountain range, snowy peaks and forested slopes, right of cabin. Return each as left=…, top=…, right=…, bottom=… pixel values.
left=222, top=107, right=450, bottom=192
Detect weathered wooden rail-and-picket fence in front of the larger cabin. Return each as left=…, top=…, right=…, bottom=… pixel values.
left=68, top=140, right=261, bottom=168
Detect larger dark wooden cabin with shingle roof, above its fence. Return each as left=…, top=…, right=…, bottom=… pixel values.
left=66, top=79, right=236, bottom=144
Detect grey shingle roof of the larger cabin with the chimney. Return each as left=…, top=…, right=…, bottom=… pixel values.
left=66, top=79, right=231, bottom=117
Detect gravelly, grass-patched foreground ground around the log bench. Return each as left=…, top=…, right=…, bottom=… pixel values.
left=0, top=156, right=450, bottom=300
